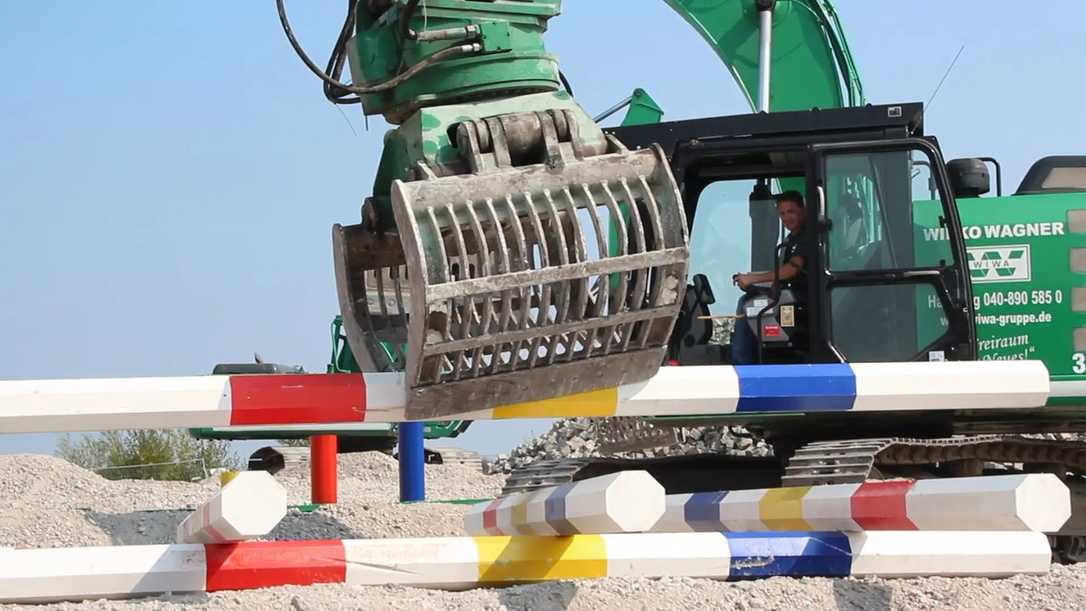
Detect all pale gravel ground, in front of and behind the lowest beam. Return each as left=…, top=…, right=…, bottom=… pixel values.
left=0, top=454, right=1086, bottom=611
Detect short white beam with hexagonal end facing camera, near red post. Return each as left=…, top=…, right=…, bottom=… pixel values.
left=176, top=471, right=287, bottom=543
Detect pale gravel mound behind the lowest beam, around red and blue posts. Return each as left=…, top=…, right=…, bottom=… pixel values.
left=0, top=453, right=504, bottom=549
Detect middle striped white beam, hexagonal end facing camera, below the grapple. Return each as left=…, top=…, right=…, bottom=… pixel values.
left=464, top=471, right=665, bottom=535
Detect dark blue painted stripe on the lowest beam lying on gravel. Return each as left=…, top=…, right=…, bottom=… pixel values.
left=722, top=532, right=853, bottom=580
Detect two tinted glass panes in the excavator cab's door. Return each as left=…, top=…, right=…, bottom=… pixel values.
left=824, top=150, right=954, bottom=362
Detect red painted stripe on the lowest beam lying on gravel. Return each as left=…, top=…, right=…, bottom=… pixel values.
left=204, top=540, right=346, bottom=591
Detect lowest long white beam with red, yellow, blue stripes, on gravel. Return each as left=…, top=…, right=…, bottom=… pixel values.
left=0, top=531, right=1051, bottom=602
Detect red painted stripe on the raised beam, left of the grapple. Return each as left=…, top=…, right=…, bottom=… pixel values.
left=230, top=373, right=366, bottom=424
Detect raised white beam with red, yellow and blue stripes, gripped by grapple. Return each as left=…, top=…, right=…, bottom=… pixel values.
left=0, top=361, right=1049, bottom=433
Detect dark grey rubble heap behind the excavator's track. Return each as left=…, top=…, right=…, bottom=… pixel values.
left=484, top=418, right=772, bottom=473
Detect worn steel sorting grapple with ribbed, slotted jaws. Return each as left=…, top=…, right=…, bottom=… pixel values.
left=334, top=111, right=687, bottom=420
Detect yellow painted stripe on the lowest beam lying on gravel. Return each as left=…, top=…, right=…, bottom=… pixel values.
left=475, top=535, right=607, bottom=584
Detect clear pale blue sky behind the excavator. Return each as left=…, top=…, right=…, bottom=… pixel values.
left=0, top=0, right=1086, bottom=460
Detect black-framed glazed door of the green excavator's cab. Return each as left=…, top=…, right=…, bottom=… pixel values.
left=808, top=138, right=976, bottom=362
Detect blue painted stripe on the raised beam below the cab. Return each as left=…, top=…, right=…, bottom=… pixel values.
left=735, top=364, right=856, bottom=412
